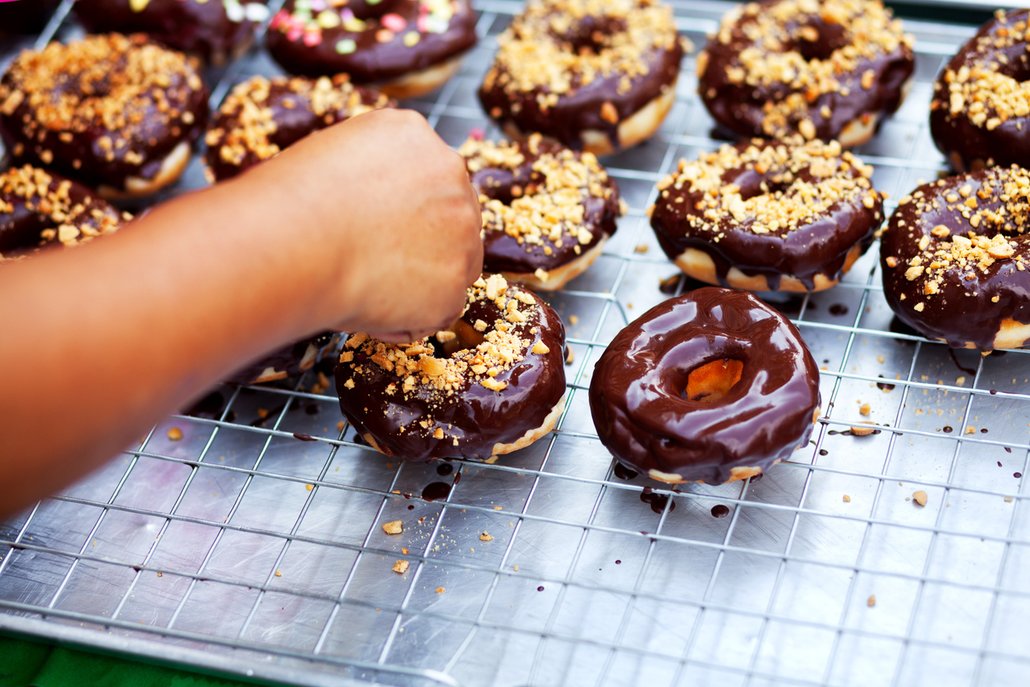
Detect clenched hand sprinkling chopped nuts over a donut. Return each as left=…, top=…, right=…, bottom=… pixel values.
left=251, top=110, right=483, bottom=341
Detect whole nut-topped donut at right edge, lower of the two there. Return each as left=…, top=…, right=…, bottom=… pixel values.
left=880, top=166, right=1030, bottom=351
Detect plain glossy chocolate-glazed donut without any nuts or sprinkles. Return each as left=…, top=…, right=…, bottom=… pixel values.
left=590, top=286, right=820, bottom=484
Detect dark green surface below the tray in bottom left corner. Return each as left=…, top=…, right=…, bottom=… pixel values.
left=0, top=636, right=269, bottom=687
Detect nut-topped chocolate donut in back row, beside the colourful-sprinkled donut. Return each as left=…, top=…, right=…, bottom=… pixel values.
left=479, top=0, right=688, bottom=154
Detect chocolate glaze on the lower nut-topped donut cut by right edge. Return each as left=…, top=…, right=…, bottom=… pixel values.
left=881, top=168, right=1030, bottom=350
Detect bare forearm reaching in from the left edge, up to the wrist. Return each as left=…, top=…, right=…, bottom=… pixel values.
left=0, top=177, right=346, bottom=513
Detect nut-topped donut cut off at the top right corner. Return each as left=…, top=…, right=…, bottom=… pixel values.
left=930, top=9, right=1030, bottom=171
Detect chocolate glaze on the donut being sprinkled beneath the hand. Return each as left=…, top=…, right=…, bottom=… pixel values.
left=336, top=284, right=565, bottom=460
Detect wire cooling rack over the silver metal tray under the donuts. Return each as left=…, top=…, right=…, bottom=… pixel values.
left=0, top=0, right=1030, bottom=686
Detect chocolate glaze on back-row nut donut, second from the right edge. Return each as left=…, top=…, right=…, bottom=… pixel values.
left=698, top=0, right=916, bottom=140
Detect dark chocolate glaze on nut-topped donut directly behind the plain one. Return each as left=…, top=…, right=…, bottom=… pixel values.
left=651, top=140, right=884, bottom=290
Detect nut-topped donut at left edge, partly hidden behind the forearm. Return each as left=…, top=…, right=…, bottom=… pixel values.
left=0, top=165, right=131, bottom=262
